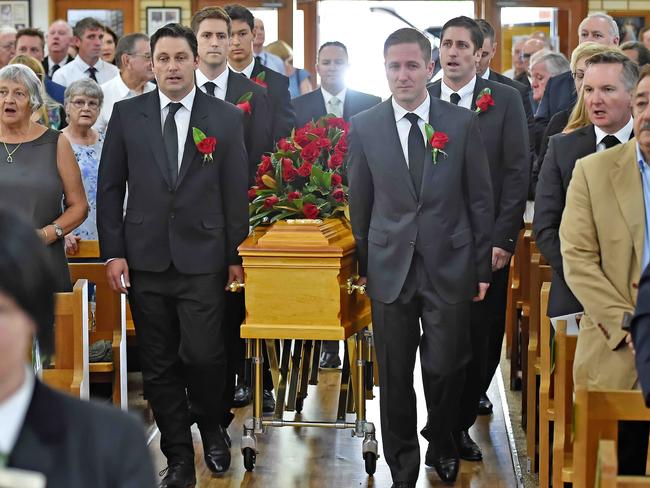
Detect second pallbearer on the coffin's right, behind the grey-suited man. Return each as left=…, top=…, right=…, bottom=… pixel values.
left=429, top=17, right=530, bottom=461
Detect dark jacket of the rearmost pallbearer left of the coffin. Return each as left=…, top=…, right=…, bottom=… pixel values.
left=251, top=59, right=296, bottom=143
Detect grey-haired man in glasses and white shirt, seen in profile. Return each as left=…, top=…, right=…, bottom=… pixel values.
left=93, top=33, right=156, bottom=132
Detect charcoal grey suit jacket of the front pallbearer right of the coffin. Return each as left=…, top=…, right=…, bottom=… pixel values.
left=348, top=98, right=492, bottom=303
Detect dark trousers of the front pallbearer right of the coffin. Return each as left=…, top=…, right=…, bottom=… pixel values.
left=372, top=256, right=470, bottom=482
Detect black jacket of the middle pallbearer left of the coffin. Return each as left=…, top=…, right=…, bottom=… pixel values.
left=226, top=69, right=273, bottom=184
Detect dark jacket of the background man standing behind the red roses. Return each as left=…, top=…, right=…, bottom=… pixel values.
left=293, top=88, right=381, bottom=127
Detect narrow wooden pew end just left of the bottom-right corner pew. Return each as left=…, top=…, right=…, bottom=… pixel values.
left=552, top=320, right=576, bottom=487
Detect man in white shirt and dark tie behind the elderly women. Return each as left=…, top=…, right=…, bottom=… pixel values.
left=52, top=17, right=119, bottom=86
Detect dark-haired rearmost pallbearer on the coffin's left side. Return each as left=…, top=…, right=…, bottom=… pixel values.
left=225, top=4, right=295, bottom=142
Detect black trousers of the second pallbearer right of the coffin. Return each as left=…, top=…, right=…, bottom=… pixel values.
left=457, top=266, right=510, bottom=431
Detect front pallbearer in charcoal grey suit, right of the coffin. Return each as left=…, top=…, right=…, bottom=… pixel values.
left=348, top=28, right=494, bottom=488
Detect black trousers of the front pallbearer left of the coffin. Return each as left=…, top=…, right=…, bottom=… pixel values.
left=129, top=266, right=226, bottom=463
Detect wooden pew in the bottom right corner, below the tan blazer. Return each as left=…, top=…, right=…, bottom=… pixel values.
left=573, top=385, right=650, bottom=487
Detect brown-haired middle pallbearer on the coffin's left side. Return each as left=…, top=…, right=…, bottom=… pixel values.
left=191, top=7, right=273, bottom=185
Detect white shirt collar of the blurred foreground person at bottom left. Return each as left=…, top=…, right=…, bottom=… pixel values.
left=0, top=365, right=35, bottom=456
